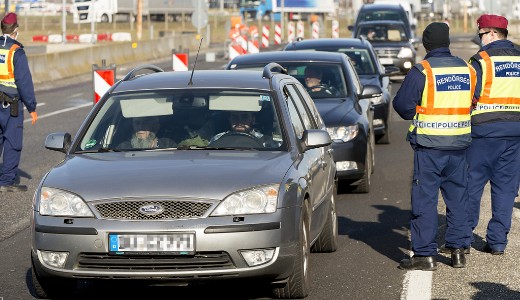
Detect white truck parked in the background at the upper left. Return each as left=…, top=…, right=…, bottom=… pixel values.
left=72, top=0, right=196, bottom=23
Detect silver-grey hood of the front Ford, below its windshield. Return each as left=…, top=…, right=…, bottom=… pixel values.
left=43, top=150, right=292, bottom=201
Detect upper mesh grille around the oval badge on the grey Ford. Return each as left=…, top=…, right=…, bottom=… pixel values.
left=94, top=201, right=212, bottom=220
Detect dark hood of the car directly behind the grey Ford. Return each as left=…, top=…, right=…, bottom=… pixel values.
left=314, top=98, right=355, bottom=127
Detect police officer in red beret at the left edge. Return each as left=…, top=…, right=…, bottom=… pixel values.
left=0, top=13, right=38, bottom=192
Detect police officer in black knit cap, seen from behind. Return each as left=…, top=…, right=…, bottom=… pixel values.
left=393, top=22, right=476, bottom=271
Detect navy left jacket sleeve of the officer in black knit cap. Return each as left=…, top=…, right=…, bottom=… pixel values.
left=392, top=67, right=426, bottom=120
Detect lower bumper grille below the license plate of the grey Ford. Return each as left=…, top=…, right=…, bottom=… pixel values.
left=76, top=252, right=235, bottom=272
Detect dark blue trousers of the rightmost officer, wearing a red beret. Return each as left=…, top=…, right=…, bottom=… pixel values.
left=467, top=138, right=520, bottom=251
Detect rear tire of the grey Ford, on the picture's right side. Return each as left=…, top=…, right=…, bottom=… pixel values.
left=311, top=189, right=338, bottom=253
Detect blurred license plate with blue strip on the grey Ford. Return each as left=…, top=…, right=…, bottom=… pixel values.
left=108, top=232, right=195, bottom=255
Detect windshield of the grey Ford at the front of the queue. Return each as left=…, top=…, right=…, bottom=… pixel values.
left=75, top=90, right=285, bottom=153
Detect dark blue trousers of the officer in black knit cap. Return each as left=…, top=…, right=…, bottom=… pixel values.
left=410, top=148, right=469, bottom=256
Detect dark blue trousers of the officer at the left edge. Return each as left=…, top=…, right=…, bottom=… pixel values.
left=0, top=102, right=23, bottom=186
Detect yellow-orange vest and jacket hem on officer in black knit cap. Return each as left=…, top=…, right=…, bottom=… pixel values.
left=409, top=57, right=477, bottom=148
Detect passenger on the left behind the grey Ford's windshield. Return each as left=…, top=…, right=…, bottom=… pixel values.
left=118, top=116, right=176, bottom=149
